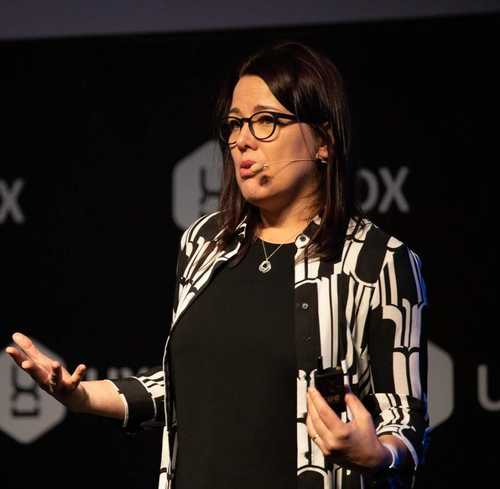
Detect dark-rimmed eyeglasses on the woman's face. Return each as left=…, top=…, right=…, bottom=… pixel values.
left=219, top=110, right=298, bottom=146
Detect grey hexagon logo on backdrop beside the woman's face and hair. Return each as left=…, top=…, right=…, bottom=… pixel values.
left=172, top=140, right=222, bottom=229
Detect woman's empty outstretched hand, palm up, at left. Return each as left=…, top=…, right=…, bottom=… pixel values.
left=5, top=333, right=87, bottom=409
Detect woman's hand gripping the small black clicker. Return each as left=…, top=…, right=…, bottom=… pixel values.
left=307, top=387, right=388, bottom=471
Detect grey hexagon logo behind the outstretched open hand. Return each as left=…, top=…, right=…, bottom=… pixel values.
left=0, top=338, right=66, bottom=443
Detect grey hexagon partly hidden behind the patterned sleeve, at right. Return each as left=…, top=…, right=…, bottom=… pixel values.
left=428, top=341, right=454, bottom=428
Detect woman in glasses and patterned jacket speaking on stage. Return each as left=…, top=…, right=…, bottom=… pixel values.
left=7, top=43, right=428, bottom=489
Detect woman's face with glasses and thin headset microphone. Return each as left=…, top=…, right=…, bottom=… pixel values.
left=230, top=75, right=325, bottom=211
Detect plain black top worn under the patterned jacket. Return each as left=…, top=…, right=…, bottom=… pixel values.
left=169, top=234, right=297, bottom=489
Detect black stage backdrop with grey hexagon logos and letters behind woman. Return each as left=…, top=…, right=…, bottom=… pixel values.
left=0, top=11, right=500, bottom=489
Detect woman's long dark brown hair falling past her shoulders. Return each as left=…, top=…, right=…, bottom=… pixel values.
left=216, top=42, right=358, bottom=259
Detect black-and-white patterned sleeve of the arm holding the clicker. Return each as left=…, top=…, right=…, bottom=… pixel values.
left=363, top=243, right=429, bottom=470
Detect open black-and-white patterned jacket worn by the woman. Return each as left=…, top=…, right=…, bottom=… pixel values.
left=113, top=212, right=428, bottom=489
